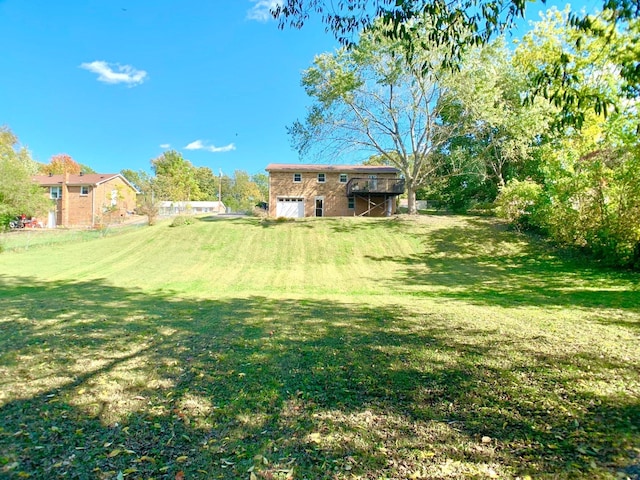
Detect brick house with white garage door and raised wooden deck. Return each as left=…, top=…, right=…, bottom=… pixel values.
left=266, top=163, right=404, bottom=218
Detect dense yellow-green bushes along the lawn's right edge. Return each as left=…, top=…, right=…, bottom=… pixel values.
left=498, top=109, right=640, bottom=268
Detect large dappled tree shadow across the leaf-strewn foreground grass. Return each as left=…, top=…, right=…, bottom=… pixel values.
left=0, top=277, right=640, bottom=479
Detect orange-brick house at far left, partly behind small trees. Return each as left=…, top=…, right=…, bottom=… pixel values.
left=33, top=173, right=138, bottom=228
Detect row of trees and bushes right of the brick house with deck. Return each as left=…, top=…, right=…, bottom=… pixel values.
left=288, top=9, right=640, bottom=267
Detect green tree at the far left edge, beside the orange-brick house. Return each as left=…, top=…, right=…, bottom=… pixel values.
left=0, top=127, right=51, bottom=227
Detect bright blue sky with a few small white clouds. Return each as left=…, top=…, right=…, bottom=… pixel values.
left=0, top=0, right=597, bottom=174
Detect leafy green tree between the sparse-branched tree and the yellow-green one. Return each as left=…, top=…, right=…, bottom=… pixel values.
left=443, top=38, right=554, bottom=192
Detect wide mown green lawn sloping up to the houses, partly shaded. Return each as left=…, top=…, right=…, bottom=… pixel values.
left=0, top=216, right=640, bottom=480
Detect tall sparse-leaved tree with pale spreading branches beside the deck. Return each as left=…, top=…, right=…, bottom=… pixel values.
left=289, top=18, right=480, bottom=214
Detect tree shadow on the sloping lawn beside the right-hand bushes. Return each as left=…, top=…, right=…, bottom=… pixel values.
left=369, top=219, right=640, bottom=316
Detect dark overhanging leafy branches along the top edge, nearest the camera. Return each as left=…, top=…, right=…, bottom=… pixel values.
left=272, top=0, right=640, bottom=125
